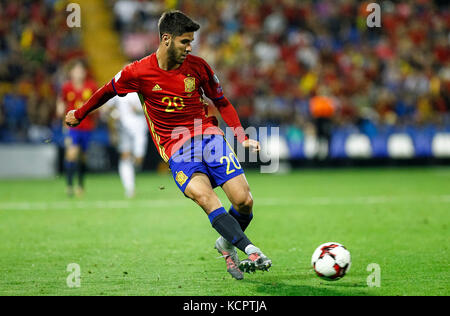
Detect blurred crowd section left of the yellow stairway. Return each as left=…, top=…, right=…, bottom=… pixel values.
left=0, top=0, right=83, bottom=142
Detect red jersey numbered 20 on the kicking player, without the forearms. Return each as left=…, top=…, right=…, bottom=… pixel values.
left=112, top=53, right=224, bottom=162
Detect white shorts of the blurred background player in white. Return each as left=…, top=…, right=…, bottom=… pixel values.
left=119, top=128, right=148, bottom=158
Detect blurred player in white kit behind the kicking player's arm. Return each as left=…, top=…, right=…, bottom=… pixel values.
left=107, top=92, right=148, bottom=198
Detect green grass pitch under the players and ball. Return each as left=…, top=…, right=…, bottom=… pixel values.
left=0, top=168, right=450, bottom=296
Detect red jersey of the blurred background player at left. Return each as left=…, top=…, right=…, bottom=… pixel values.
left=61, top=79, right=98, bottom=131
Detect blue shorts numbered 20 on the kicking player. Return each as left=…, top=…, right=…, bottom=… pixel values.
left=169, top=135, right=244, bottom=193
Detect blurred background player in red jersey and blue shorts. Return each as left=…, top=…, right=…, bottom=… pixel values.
left=57, top=60, right=98, bottom=196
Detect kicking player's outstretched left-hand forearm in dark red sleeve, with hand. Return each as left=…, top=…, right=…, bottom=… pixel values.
left=66, top=82, right=116, bottom=126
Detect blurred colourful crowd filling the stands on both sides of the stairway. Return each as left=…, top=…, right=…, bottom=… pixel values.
left=0, top=0, right=450, bottom=148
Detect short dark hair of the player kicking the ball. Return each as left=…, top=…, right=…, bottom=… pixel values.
left=158, top=10, right=200, bottom=39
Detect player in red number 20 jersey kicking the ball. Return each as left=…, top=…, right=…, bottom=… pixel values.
left=66, top=11, right=272, bottom=279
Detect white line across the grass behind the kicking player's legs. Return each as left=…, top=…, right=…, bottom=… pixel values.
left=0, top=195, right=450, bottom=211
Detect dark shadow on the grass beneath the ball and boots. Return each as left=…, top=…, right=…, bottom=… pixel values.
left=241, top=277, right=369, bottom=296
